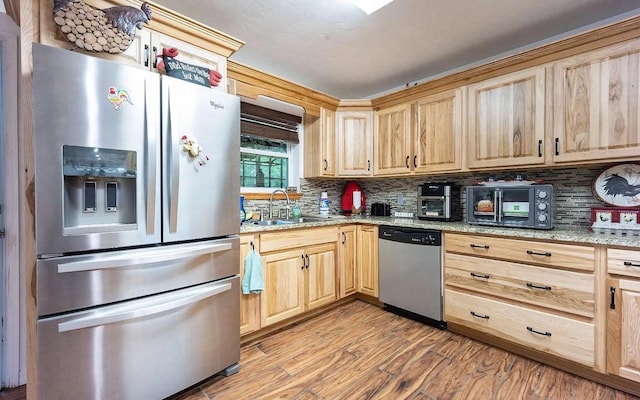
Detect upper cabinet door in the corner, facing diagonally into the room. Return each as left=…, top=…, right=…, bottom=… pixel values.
left=336, top=111, right=373, bottom=176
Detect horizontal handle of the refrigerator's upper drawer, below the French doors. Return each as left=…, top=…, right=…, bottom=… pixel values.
left=58, top=243, right=232, bottom=274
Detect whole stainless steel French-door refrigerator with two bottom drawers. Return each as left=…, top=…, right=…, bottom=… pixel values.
left=33, top=44, right=240, bottom=400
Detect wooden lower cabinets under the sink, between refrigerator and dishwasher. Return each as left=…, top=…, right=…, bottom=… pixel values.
left=240, top=224, right=378, bottom=335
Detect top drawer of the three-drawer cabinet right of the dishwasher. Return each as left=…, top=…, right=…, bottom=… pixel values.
left=444, top=233, right=595, bottom=271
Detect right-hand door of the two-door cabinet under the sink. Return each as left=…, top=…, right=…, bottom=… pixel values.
left=305, top=243, right=337, bottom=310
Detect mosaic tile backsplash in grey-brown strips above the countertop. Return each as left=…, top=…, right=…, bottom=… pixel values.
left=245, top=165, right=606, bottom=228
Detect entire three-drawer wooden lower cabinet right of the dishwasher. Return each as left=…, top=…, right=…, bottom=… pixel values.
left=445, top=233, right=604, bottom=369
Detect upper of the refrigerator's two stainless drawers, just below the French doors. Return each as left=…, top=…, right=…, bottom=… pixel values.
left=36, top=237, right=240, bottom=317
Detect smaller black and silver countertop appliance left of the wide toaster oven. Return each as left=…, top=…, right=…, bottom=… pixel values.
left=418, top=182, right=462, bottom=222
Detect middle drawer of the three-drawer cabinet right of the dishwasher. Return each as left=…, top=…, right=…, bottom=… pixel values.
left=445, top=253, right=595, bottom=317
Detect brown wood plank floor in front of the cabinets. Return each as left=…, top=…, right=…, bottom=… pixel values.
left=174, top=301, right=638, bottom=400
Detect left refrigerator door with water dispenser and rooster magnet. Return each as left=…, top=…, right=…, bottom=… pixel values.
left=33, top=44, right=161, bottom=255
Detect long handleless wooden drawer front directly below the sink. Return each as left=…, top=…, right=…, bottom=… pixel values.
left=260, top=226, right=338, bottom=253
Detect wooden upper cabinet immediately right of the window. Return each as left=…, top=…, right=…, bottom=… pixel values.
left=304, top=108, right=336, bottom=178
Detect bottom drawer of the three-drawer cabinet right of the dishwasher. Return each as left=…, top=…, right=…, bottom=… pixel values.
left=444, top=289, right=595, bottom=367
